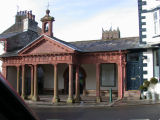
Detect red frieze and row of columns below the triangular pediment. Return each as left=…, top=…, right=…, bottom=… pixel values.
left=0, top=47, right=126, bottom=103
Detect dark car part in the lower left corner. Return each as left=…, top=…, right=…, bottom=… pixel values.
left=0, top=73, right=39, bottom=120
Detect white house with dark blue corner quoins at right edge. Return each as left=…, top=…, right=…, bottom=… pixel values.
left=138, top=0, right=160, bottom=80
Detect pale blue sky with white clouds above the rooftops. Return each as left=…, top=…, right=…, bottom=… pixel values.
left=0, top=0, right=139, bottom=41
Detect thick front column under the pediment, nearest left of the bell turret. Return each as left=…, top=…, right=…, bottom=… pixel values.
left=32, top=65, right=39, bottom=101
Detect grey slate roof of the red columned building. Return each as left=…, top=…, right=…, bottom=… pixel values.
left=0, top=36, right=150, bottom=57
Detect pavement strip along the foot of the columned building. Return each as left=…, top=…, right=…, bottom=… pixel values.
left=25, top=95, right=160, bottom=108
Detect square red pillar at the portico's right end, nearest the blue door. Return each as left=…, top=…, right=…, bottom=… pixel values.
left=118, top=56, right=124, bottom=99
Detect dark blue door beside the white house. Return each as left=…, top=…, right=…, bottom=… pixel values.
left=127, top=61, right=141, bottom=90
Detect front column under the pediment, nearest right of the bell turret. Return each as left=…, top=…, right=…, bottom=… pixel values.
left=52, top=64, right=60, bottom=103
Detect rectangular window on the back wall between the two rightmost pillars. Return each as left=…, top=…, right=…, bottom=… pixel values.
left=101, top=64, right=116, bottom=87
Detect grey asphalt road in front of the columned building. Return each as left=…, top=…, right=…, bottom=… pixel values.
left=32, top=104, right=160, bottom=120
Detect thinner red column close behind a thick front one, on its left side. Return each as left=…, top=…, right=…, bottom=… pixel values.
left=29, top=65, right=34, bottom=99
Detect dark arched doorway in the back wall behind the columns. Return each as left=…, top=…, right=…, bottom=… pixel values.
left=63, top=66, right=86, bottom=94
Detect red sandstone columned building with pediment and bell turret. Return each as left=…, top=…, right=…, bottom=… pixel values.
left=1, top=10, right=127, bottom=103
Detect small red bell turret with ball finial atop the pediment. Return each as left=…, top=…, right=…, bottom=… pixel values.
left=41, top=9, right=55, bottom=37
